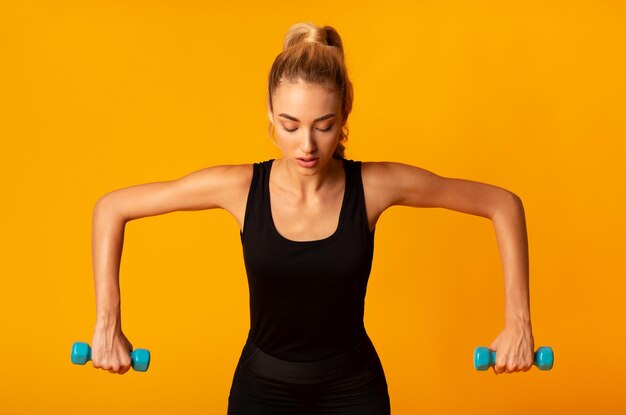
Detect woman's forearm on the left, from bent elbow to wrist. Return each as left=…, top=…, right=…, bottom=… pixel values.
left=91, top=199, right=126, bottom=324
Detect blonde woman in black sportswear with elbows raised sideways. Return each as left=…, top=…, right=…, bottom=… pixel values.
left=92, top=23, right=534, bottom=414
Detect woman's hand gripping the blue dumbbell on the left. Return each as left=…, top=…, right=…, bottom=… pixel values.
left=91, top=318, right=133, bottom=375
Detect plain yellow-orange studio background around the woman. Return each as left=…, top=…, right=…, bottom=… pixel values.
left=0, top=1, right=626, bottom=415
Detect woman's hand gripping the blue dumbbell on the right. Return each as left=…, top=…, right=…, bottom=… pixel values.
left=489, top=322, right=535, bottom=375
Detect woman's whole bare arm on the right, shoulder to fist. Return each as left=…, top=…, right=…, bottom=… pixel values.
left=374, top=162, right=534, bottom=373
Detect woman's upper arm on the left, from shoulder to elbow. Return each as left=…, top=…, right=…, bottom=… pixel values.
left=96, top=164, right=252, bottom=220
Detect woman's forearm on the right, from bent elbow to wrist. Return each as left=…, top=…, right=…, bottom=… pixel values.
left=492, top=197, right=530, bottom=326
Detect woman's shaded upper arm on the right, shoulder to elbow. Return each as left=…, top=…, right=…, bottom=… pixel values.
left=375, top=162, right=519, bottom=218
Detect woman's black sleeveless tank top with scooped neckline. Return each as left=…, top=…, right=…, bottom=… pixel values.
left=240, top=159, right=376, bottom=361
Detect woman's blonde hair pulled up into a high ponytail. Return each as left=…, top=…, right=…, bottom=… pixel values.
left=268, top=22, right=354, bottom=158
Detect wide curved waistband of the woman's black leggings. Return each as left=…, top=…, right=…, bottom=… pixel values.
left=241, top=335, right=373, bottom=384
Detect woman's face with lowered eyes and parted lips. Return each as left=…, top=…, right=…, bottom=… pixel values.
left=268, top=81, right=342, bottom=172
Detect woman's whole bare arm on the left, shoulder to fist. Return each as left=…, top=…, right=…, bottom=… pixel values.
left=92, top=165, right=250, bottom=374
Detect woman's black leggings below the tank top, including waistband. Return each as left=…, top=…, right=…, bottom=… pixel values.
left=228, top=334, right=391, bottom=415
